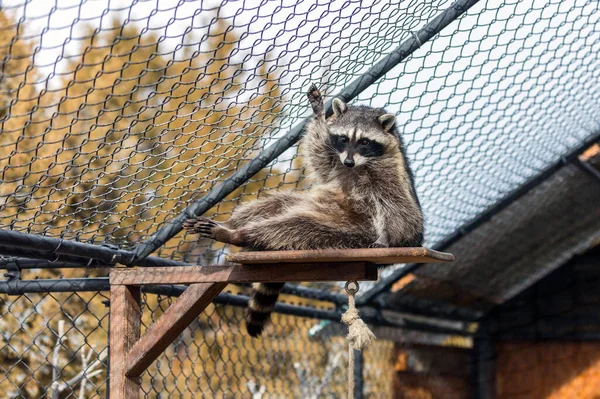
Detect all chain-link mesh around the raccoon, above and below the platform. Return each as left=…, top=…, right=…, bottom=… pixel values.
left=0, top=0, right=600, bottom=399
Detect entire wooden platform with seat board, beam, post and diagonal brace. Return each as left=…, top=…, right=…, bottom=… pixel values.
left=109, top=248, right=454, bottom=399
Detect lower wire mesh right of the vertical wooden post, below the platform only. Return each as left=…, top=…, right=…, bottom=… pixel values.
left=142, top=290, right=393, bottom=398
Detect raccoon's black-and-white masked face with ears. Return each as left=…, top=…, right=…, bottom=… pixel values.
left=329, top=98, right=398, bottom=168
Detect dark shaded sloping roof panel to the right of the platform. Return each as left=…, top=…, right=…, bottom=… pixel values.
left=389, top=156, right=600, bottom=310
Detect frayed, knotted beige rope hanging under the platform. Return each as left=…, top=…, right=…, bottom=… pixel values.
left=342, top=281, right=375, bottom=399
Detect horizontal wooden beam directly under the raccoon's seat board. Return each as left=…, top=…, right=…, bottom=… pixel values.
left=110, top=262, right=377, bottom=285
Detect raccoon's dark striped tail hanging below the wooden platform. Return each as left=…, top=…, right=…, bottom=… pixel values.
left=246, top=283, right=285, bottom=338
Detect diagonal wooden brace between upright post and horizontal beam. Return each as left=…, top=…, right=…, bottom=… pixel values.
left=125, top=283, right=227, bottom=378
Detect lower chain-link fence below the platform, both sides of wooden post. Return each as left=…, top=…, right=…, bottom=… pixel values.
left=0, top=287, right=393, bottom=399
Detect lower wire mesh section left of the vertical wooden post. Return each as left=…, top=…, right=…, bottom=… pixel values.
left=0, top=292, right=109, bottom=399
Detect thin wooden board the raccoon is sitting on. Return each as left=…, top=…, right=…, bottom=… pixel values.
left=227, top=247, right=454, bottom=265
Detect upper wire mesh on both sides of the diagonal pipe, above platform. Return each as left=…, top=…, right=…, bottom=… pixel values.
left=0, top=0, right=600, bottom=261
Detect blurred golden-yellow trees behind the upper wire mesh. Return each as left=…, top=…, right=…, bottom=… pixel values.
left=0, top=14, right=290, bottom=253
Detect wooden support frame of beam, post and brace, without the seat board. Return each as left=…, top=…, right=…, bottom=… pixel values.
left=109, top=262, right=377, bottom=399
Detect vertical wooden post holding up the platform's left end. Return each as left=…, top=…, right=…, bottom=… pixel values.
left=110, top=285, right=142, bottom=399
